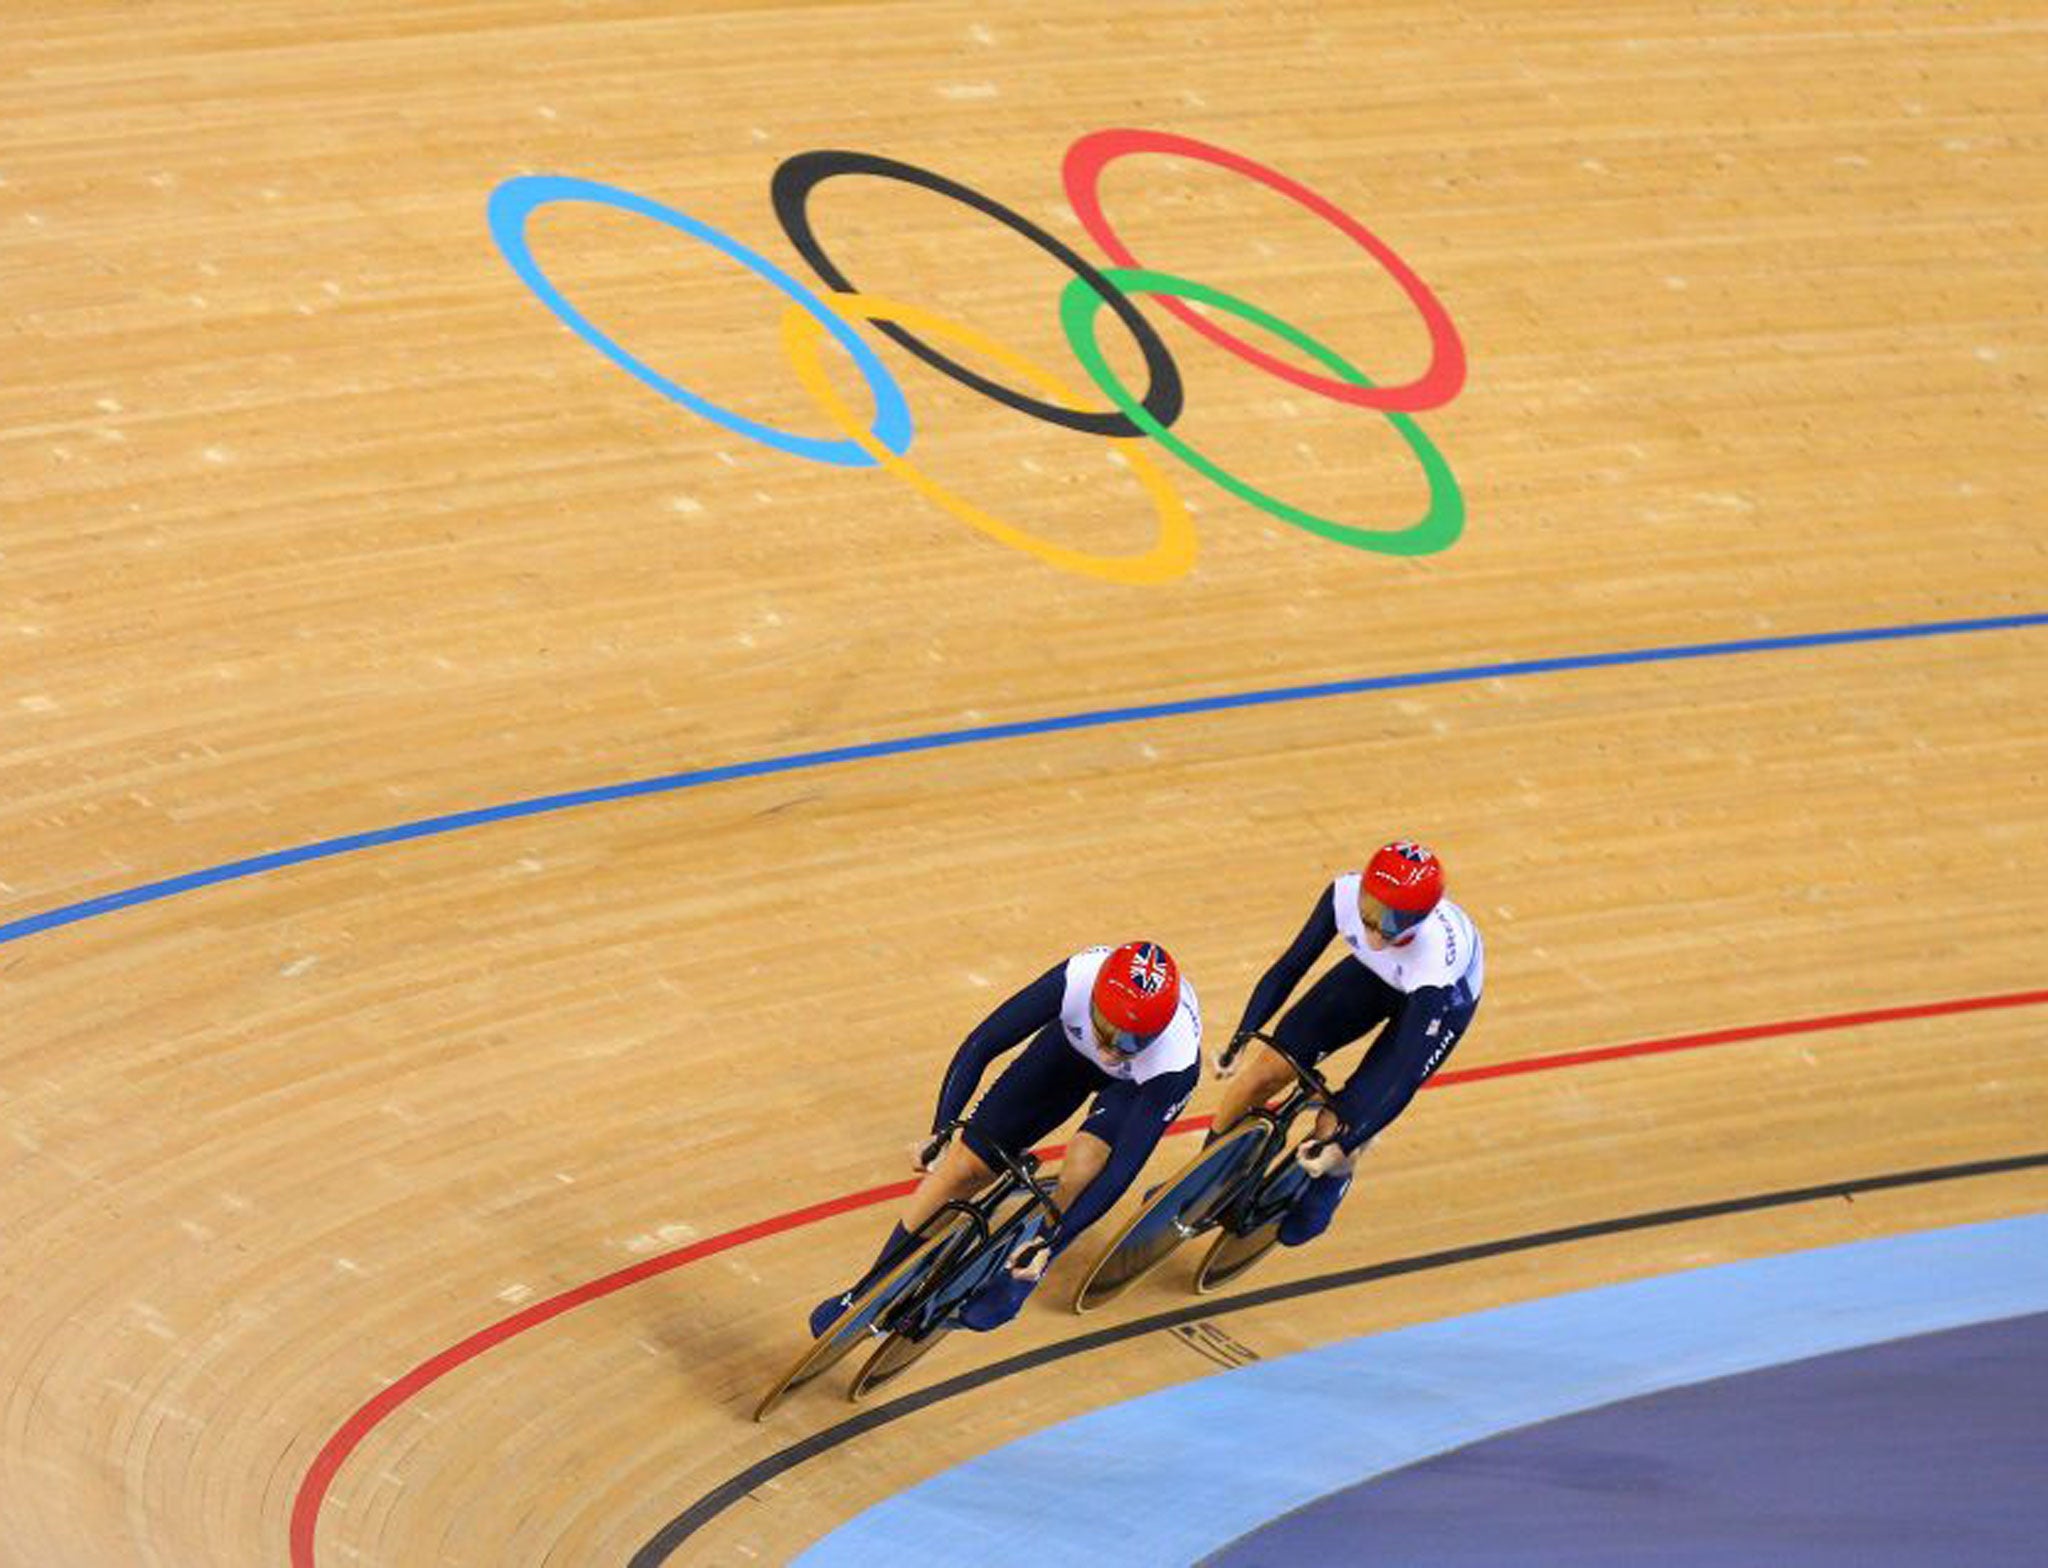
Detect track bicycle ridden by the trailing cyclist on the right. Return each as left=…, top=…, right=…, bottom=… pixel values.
left=1073, top=1032, right=1333, bottom=1312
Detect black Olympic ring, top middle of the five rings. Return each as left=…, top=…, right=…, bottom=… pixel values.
left=768, top=147, right=1182, bottom=436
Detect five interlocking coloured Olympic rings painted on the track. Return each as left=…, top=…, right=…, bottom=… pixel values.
left=489, top=129, right=1464, bottom=583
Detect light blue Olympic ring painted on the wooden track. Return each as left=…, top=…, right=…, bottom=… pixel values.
left=489, top=174, right=911, bottom=469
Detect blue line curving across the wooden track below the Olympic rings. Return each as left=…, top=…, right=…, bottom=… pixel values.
left=0, top=612, right=2048, bottom=944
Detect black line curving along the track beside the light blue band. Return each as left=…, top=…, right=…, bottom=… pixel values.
left=627, top=1150, right=2048, bottom=1568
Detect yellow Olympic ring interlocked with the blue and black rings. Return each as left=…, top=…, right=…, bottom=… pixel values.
left=782, top=293, right=1194, bottom=583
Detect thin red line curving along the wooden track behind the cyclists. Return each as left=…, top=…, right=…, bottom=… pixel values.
left=291, top=991, right=2048, bottom=1568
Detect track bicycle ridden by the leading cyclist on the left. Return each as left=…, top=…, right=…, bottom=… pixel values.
left=754, top=1122, right=1059, bottom=1421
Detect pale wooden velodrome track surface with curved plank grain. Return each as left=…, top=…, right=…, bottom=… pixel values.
left=0, top=0, right=2048, bottom=1568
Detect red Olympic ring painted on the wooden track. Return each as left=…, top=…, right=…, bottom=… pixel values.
left=1061, top=129, right=1464, bottom=413
